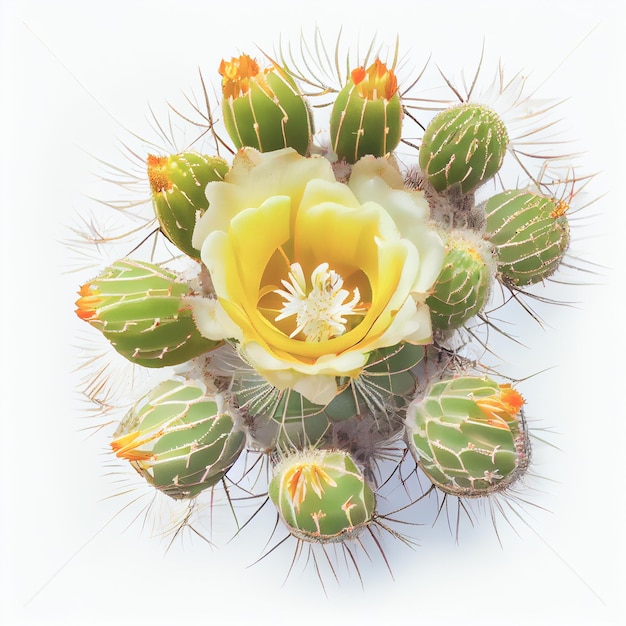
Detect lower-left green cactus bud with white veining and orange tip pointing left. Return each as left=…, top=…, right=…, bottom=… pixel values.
left=111, top=380, right=246, bottom=499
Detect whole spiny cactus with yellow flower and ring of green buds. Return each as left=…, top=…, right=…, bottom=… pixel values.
left=70, top=29, right=596, bottom=584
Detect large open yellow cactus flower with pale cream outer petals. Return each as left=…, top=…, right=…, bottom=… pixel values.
left=190, top=148, right=443, bottom=404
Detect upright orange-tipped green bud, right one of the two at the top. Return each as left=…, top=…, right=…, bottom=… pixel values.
left=330, top=59, right=402, bottom=163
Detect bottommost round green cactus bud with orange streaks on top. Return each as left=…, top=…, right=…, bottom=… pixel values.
left=269, top=450, right=375, bottom=542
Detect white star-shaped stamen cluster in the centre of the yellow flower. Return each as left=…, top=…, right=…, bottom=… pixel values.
left=274, top=263, right=366, bottom=342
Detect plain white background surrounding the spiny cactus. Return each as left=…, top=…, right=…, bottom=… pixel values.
left=0, top=0, right=626, bottom=626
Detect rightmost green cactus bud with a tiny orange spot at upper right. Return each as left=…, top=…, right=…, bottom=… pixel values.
left=485, top=190, right=569, bottom=287
